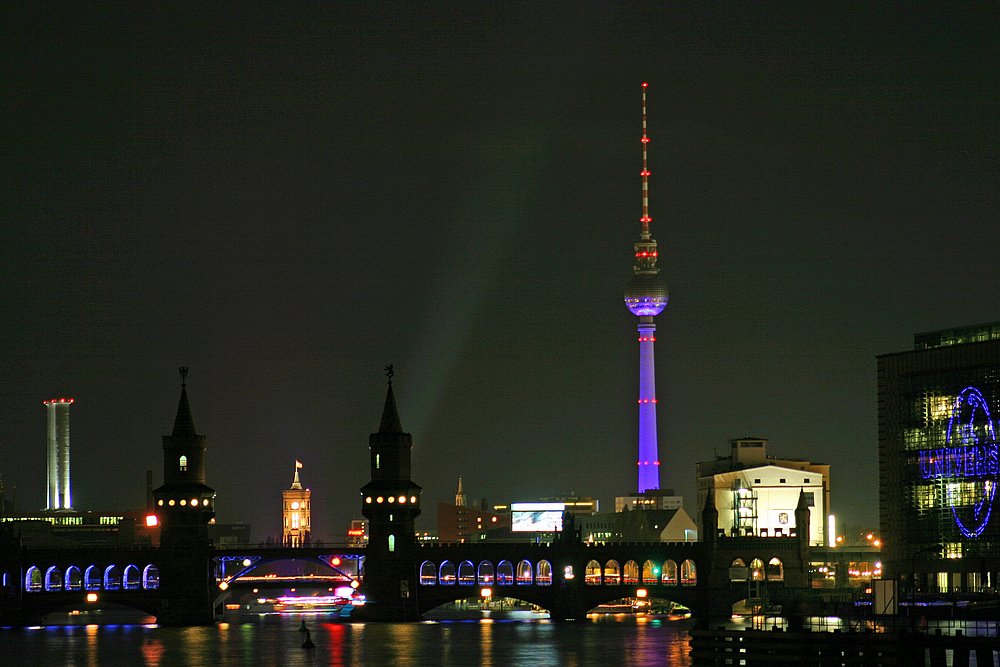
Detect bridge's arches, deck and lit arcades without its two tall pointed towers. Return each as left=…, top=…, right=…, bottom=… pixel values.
left=5, top=537, right=804, bottom=624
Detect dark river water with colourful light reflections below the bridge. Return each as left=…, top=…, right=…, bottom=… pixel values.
left=0, top=614, right=691, bottom=667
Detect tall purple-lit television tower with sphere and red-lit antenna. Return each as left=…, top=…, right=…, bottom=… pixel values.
left=625, top=83, right=667, bottom=493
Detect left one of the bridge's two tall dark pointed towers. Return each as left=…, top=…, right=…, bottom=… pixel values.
left=153, top=368, right=215, bottom=626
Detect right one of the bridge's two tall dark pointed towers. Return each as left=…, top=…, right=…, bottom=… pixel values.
left=356, top=365, right=421, bottom=621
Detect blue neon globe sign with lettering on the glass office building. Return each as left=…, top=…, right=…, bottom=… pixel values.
left=917, top=387, right=1000, bottom=537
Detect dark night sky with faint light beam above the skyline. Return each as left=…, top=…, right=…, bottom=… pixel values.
left=0, top=2, right=1000, bottom=540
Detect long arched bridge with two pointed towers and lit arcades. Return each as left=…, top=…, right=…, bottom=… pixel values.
left=0, top=382, right=810, bottom=626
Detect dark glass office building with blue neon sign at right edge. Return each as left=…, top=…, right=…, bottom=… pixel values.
left=878, top=322, right=1000, bottom=593
